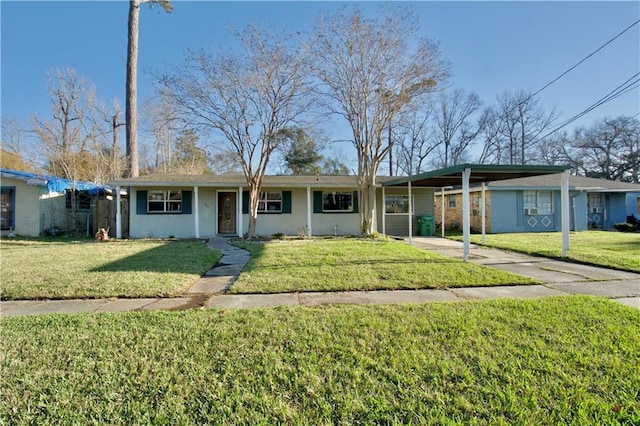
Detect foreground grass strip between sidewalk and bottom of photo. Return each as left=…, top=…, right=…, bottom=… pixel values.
left=0, top=296, right=640, bottom=425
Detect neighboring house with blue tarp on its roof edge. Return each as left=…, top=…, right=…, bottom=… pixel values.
left=0, top=169, right=118, bottom=237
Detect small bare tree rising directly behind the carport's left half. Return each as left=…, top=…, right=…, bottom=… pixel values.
left=435, top=89, right=484, bottom=167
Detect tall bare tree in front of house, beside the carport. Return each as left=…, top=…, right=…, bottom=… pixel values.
left=311, top=9, right=446, bottom=235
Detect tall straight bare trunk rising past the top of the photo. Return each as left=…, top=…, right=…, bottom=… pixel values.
left=125, top=0, right=173, bottom=177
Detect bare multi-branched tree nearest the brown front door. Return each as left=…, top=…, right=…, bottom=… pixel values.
left=161, top=27, right=309, bottom=237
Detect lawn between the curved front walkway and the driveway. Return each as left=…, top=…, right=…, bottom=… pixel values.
left=230, top=238, right=536, bottom=293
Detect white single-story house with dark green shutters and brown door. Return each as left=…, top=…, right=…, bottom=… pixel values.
left=112, top=175, right=434, bottom=238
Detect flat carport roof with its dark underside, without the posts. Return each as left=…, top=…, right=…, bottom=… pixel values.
left=382, top=164, right=571, bottom=188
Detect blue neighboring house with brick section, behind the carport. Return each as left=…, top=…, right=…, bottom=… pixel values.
left=435, top=174, right=640, bottom=233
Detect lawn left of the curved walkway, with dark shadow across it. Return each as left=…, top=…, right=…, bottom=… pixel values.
left=0, top=239, right=220, bottom=300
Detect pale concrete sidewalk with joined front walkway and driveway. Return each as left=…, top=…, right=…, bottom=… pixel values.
left=0, top=237, right=640, bottom=316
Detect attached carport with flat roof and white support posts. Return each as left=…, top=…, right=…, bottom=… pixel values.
left=382, top=164, right=570, bottom=261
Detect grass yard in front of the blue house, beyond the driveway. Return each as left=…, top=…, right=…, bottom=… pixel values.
left=452, top=231, right=640, bottom=272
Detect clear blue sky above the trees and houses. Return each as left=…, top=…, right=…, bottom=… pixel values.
left=0, top=0, right=640, bottom=169
